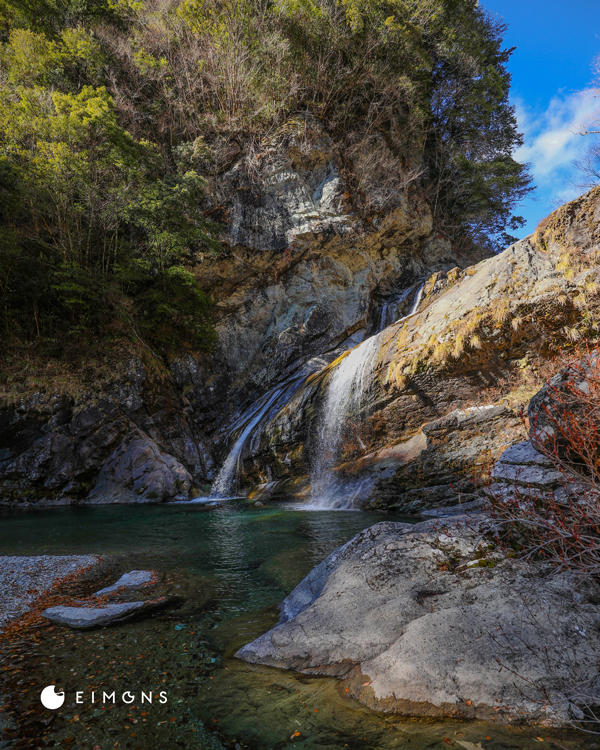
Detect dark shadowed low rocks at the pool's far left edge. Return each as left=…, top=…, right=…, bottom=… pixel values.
left=0, top=360, right=202, bottom=503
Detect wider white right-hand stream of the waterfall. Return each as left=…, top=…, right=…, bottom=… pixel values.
left=309, top=283, right=424, bottom=510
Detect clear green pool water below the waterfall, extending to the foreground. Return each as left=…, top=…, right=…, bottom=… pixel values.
left=0, top=505, right=600, bottom=750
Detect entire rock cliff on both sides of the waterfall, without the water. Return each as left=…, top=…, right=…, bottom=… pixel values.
left=0, top=123, right=600, bottom=509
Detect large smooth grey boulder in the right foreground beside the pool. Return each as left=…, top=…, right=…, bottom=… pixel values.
left=237, top=517, right=600, bottom=725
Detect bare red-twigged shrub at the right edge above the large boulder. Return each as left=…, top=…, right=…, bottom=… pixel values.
left=494, top=350, right=600, bottom=575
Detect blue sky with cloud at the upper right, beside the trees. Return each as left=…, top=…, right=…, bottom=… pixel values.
left=480, top=0, right=600, bottom=236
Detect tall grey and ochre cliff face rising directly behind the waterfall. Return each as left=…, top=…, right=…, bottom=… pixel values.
left=198, top=116, right=481, bottom=406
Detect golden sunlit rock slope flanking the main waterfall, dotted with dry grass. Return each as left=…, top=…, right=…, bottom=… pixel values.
left=239, top=189, right=600, bottom=510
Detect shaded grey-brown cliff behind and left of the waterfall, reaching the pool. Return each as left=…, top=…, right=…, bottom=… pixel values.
left=0, top=121, right=476, bottom=502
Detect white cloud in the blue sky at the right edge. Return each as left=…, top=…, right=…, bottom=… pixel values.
left=515, top=88, right=600, bottom=182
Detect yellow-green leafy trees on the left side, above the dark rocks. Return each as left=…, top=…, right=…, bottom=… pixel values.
left=0, top=17, right=217, bottom=350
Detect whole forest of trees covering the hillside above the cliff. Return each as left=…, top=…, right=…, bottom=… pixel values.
left=0, top=0, right=528, bottom=348
